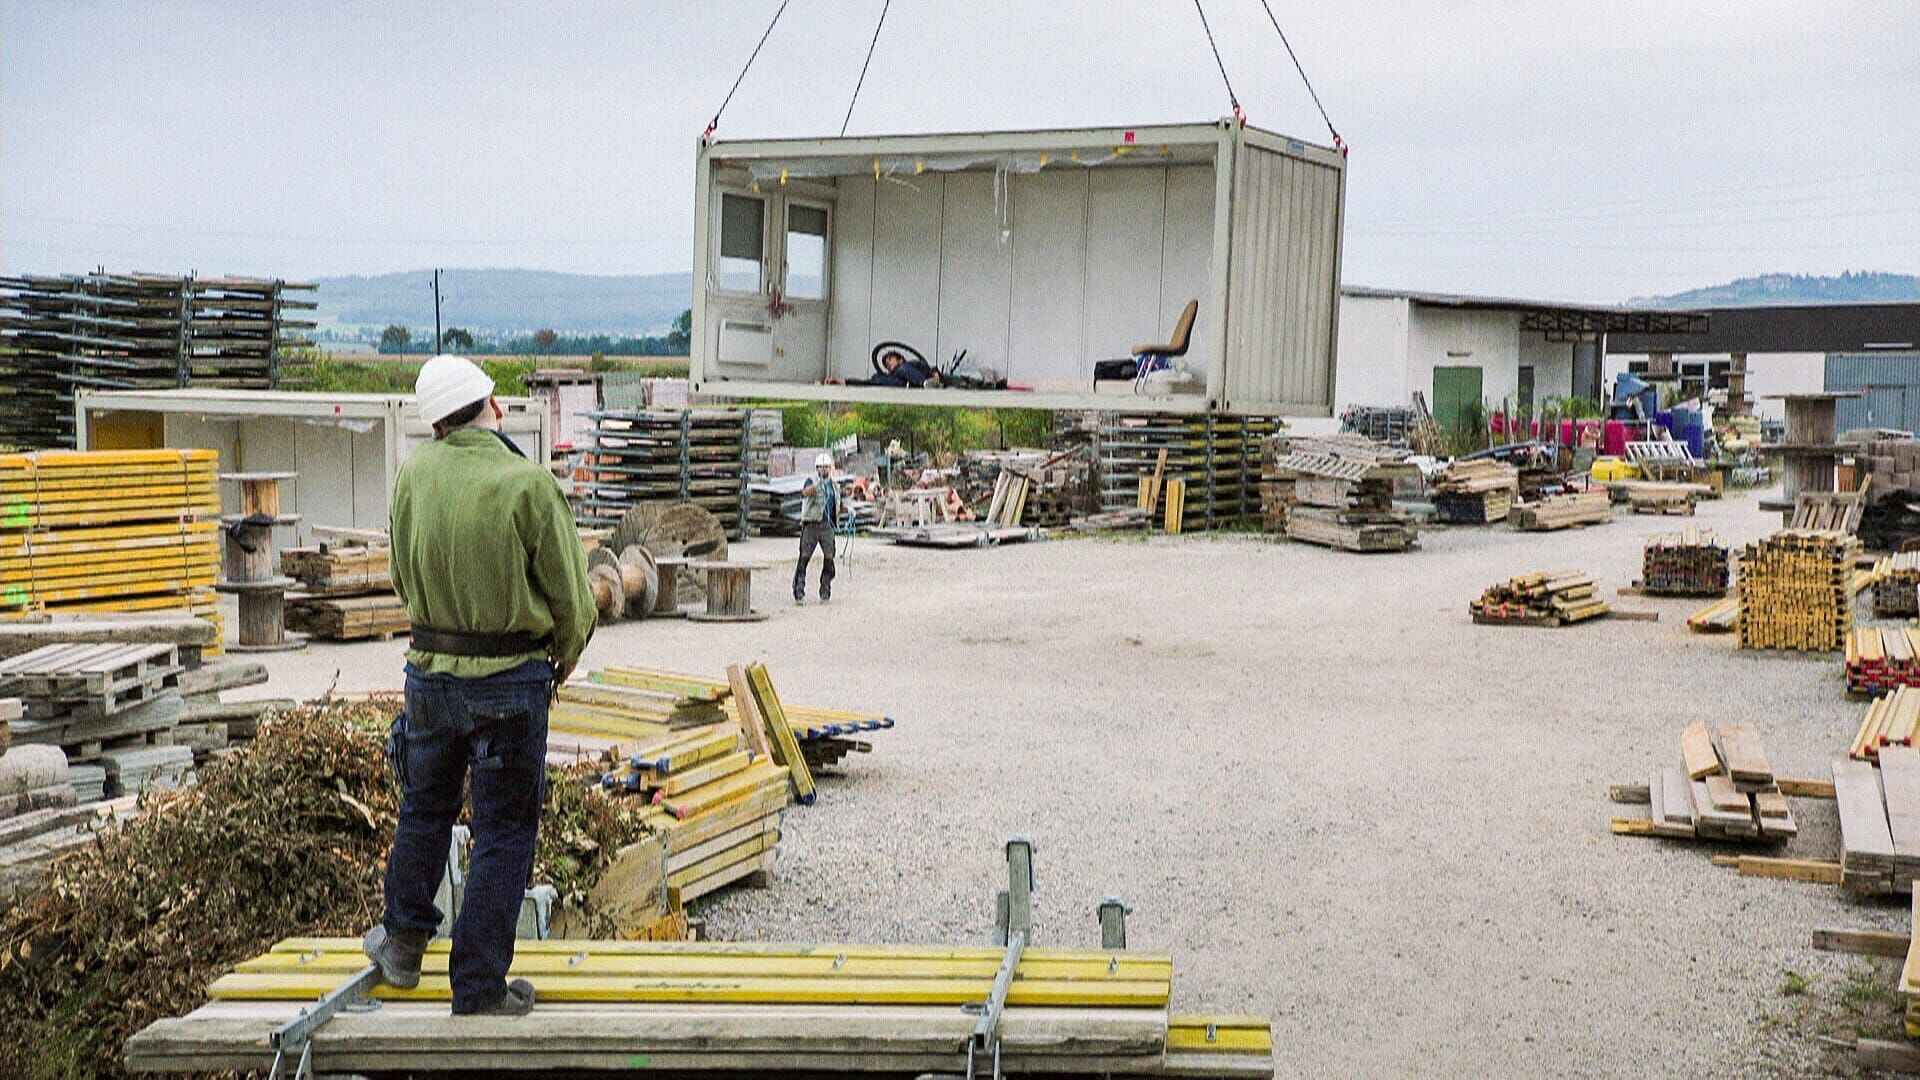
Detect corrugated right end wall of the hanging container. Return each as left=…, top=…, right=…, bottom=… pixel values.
left=1227, top=144, right=1342, bottom=415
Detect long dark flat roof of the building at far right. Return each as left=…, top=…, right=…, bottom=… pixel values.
left=1607, top=300, right=1920, bottom=354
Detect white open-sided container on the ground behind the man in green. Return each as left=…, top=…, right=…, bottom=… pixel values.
left=75, top=390, right=553, bottom=546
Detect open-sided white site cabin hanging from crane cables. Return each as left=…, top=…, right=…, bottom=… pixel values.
left=691, top=119, right=1346, bottom=417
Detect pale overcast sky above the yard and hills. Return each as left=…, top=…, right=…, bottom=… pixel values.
left=0, top=0, right=1920, bottom=300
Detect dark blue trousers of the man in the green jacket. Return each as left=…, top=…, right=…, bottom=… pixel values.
left=386, top=659, right=553, bottom=1013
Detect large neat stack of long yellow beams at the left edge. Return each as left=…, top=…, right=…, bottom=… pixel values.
left=0, top=450, right=221, bottom=638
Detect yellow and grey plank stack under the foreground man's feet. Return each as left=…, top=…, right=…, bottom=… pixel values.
left=127, top=938, right=1273, bottom=1078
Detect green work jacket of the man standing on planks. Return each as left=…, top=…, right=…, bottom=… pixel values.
left=390, top=429, right=597, bottom=678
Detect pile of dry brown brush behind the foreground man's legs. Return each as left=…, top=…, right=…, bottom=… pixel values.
left=0, top=698, right=639, bottom=1078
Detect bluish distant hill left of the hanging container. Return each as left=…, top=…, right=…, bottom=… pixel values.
left=315, top=269, right=693, bottom=336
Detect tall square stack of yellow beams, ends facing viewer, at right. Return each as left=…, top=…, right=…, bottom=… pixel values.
left=1738, top=528, right=1859, bottom=651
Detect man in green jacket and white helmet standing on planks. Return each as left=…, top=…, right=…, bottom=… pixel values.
left=365, top=356, right=595, bottom=1017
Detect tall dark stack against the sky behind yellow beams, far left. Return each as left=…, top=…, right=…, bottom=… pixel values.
left=0, top=271, right=315, bottom=450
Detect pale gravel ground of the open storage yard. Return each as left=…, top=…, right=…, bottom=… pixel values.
left=257, top=496, right=1905, bottom=1076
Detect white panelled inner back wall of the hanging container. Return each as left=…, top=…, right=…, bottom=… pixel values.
left=828, top=165, right=1217, bottom=392
